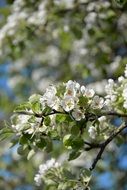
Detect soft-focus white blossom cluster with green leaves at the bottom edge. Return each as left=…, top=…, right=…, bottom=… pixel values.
left=34, top=158, right=91, bottom=190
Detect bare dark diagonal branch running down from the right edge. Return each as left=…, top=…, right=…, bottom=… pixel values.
left=90, top=125, right=127, bottom=171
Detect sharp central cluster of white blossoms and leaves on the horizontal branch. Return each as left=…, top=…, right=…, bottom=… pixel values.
left=12, top=80, right=106, bottom=144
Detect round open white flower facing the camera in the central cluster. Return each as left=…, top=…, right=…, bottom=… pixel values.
left=61, top=96, right=75, bottom=112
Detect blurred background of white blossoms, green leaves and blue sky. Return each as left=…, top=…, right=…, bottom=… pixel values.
left=0, top=0, right=127, bottom=190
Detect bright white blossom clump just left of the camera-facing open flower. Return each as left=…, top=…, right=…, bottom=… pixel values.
left=40, top=86, right=59, bottom=109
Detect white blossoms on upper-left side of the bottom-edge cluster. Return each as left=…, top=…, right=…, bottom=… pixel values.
left=34, top=158, right=60, bottom=186
